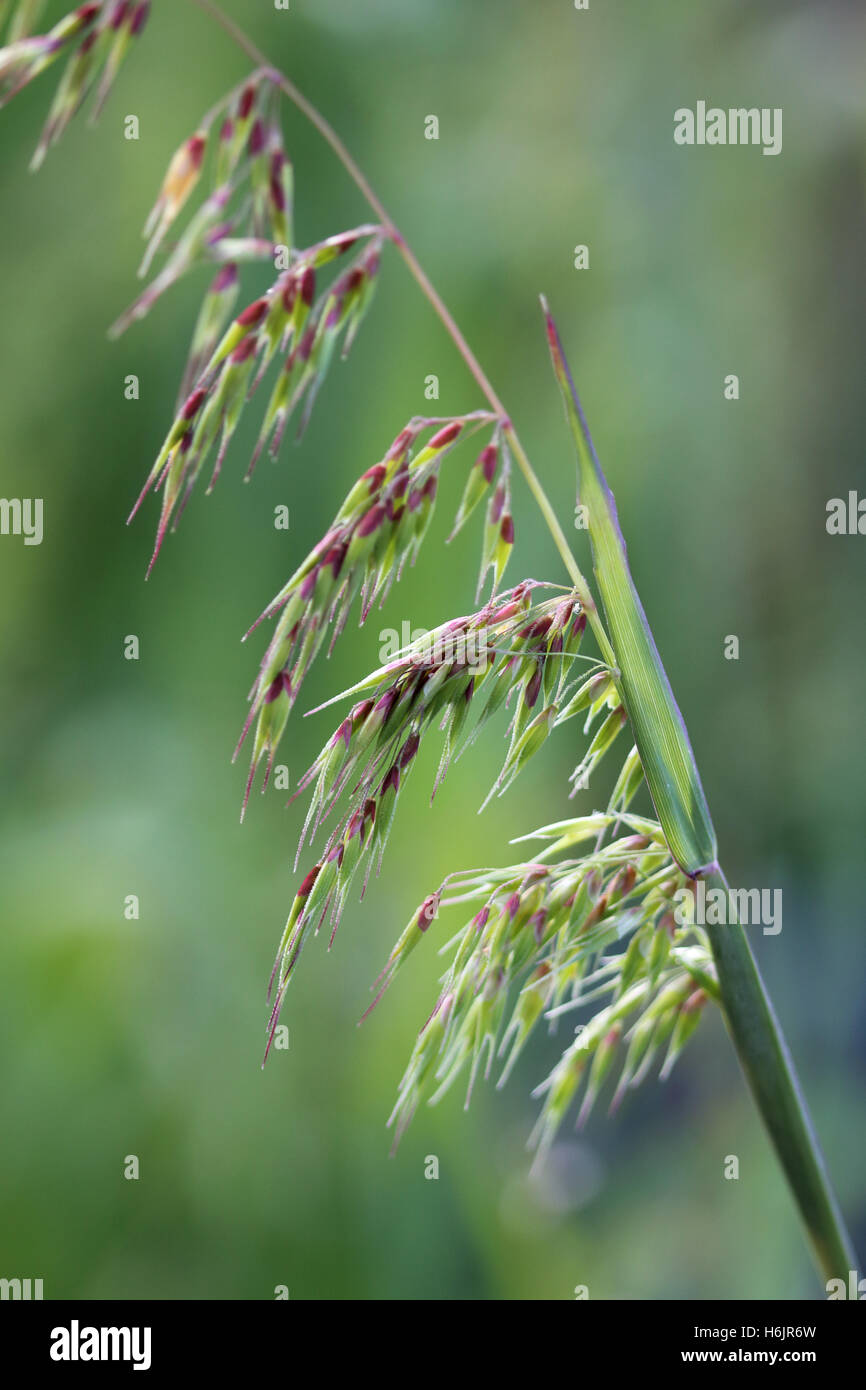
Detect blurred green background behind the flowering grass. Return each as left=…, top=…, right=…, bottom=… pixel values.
left=0, top=0, right=866, bottom=1300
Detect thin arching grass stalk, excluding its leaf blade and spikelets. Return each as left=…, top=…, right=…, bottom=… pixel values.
left=186, top=0, right=858, bottom=1279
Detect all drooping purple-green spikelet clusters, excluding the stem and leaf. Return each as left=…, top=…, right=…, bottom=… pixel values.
left=0, top=19, right=739, bottom=1173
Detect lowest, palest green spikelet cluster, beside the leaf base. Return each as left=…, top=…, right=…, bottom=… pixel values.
left=374, top=809, right=719, bottom=1158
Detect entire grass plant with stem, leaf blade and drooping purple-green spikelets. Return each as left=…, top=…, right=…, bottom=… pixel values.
left=0, top=0, right=856, bottom=1277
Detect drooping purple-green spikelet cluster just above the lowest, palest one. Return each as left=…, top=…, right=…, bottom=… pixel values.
left=265, top=580, right=650, bottom=1055
